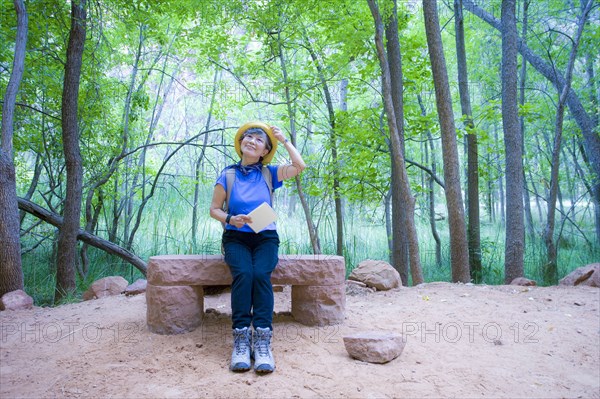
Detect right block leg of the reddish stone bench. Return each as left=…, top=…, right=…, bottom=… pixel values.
left=292, top=284, right=346, bottom=326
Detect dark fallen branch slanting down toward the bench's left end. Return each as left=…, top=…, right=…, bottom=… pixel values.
left=17, top=197, right=146, bottom=276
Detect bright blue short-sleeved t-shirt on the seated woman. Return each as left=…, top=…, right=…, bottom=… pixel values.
left=215, top=165, right=283, bottom=233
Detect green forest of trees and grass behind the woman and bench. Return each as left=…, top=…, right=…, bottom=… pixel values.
left=0, top=0, right=600, bottom=305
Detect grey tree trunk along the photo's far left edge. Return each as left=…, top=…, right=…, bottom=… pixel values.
left=0, top=0, right=28, bottom=297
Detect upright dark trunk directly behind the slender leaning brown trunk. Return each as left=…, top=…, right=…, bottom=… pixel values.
left=385, top=0, right=410, bottom=285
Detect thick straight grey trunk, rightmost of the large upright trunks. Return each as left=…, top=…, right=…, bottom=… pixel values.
left=502, top=0, right=525, bottom=284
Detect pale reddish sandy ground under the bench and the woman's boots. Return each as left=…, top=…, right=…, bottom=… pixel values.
left=0, top=283, right=600, bottom=398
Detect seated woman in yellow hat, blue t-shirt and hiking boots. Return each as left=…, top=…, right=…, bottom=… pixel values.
left=210, top=122, right=306, bottom=373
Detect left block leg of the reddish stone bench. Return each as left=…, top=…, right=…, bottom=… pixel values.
left=146, top=284, right=204, bottom=334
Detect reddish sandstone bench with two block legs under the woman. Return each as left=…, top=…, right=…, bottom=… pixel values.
left=146, top=255, right=346, bottom=334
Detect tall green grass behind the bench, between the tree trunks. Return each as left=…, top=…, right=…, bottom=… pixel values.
left=23, top=185, right=600, bottom=305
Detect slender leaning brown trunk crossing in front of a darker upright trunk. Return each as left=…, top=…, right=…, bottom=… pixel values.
left=367, top=0, right=423, bottom=285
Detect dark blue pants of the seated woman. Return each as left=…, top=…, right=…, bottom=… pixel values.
left=223, top=230, right=279, bottom=330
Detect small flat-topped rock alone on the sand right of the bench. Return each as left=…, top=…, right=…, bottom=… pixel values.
left=344, top=331, right=406, bottom=363
